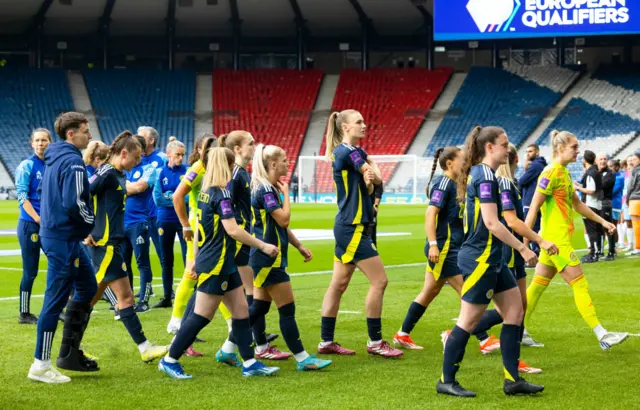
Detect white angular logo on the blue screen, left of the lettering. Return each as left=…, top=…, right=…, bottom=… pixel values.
left=467, top=0, right=521, bottom=33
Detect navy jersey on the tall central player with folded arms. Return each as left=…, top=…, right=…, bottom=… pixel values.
left=332, top=143, right=373, bottom=225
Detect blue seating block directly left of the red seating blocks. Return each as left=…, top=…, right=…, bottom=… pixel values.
left=84, top=69, right=196, bottom=151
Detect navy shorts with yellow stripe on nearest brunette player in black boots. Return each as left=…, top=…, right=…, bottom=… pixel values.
left=458, top=257, right=518, bottom=305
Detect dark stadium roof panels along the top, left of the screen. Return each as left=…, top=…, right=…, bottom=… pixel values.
left=0, top=0, right=433, bottom=37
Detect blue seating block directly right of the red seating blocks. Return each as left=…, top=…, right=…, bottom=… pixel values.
left=425, top=67, right=579, bottom=156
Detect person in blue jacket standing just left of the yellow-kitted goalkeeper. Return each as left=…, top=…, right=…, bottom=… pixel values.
left=153, top=137, right=187, bottom=308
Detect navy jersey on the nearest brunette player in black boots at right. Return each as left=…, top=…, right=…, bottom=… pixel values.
left=458, top=164, right=502, bottom=266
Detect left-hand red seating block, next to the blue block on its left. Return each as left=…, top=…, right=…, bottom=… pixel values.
left=213, top=69, right=323, bottom=180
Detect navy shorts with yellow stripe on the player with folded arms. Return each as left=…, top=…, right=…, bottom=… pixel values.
left=333, top=224, right=378, bottom=264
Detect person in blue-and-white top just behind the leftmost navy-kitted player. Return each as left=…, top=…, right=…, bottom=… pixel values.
left=123, top=135, right=157, bottom=313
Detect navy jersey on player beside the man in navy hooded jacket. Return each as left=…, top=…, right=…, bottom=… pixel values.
left=89, top=164, right=127, bottom=246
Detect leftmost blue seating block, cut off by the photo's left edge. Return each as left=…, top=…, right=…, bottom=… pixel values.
left=0, top=69, right=74, bottom=178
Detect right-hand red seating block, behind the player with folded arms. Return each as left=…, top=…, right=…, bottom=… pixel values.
left=316, top=67, right=453, bottom=192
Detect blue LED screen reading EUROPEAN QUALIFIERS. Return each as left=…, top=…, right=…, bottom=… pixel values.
left=434, top=0, right=640, bottom=41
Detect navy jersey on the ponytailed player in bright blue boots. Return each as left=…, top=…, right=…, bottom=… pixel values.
left=196, top=187, right=238, bottom=275
